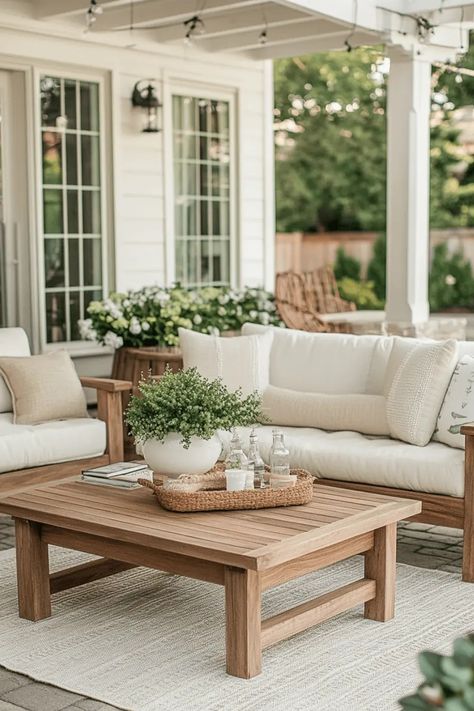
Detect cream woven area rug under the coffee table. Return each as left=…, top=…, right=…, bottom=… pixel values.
left=0, top=548, right=474, bottom=711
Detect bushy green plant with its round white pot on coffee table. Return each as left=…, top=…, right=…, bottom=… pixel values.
left=125, top=368, right=261, bottom=477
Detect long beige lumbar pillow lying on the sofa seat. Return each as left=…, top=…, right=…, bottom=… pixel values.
left=262, top=385, right=390, bottom=435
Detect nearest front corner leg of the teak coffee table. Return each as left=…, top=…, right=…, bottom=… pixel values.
left=225, top=567, right=262, bottom=679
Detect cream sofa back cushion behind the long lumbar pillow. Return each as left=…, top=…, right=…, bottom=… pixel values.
left=242, top=323, right=393, bottom=395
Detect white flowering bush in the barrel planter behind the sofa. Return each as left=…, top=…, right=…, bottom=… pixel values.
left=79, top=285, right=283, bottom=348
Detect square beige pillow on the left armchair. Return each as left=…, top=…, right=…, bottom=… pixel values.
left=0, top=351, right=88, bottom=425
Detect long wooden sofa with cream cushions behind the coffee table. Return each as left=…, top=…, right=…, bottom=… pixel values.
left=222, top=324, right=474, bottom=582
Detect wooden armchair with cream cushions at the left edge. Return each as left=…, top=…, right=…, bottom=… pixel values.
left=0, top=328, right=131, bottom=495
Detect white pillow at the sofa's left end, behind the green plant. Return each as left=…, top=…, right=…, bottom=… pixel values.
left=179, top=328, right=273, bottom=395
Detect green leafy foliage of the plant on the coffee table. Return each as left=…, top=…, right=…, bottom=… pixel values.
left=125, top=368, right=264, bottom=449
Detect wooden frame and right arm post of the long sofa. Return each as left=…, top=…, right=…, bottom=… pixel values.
left=318, top=425, right=474, bottom=583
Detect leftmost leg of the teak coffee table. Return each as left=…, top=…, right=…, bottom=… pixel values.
left=15, top=519, right=51, bottom=622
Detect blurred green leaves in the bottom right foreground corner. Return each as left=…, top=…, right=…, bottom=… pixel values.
left=400, top=634, right=474, bottom=711
